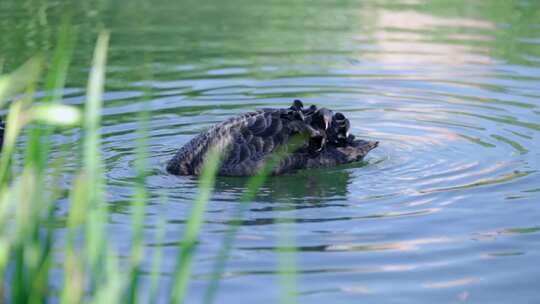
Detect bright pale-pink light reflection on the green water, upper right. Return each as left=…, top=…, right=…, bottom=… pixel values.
left=368, top=9, right=495, bottom=65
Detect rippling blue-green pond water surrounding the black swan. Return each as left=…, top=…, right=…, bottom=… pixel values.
left=0, top=0, right=540, bottom=303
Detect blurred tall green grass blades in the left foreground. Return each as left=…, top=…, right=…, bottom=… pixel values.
left=0, top=23, right=296, bottom=303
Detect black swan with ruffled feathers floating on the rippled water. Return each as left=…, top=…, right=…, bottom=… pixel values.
left=167, top=100, right=379, bottom=176
